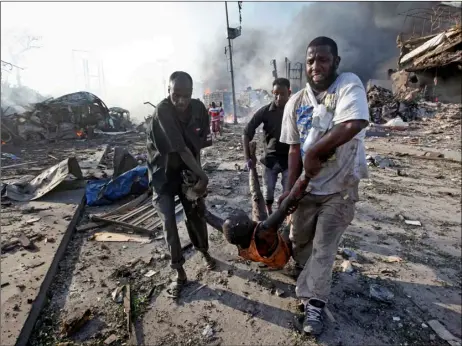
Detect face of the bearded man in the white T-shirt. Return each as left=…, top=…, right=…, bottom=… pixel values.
left=306, top=46, right=340, bottom=91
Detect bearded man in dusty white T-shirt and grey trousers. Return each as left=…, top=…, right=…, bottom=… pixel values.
left=279, top=37, right=369, bottom=335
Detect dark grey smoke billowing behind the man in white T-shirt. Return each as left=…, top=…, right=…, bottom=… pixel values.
left=201, top=2, right=435, bottom=91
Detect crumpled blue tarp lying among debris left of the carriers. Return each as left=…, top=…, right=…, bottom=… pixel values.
left=85, top=166, right=149, bottom=206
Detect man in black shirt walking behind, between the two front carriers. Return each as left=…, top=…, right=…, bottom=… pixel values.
left=242, top=78, right=290, bottom=215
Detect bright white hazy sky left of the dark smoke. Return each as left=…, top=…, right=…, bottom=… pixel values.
left=1, top=2, right=307, bottom=117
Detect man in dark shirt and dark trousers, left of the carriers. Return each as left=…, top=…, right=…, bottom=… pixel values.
left=147, top=71, right=215, bottom=298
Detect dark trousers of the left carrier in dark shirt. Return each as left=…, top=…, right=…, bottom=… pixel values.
left=152, top=192, right=209, bottom=269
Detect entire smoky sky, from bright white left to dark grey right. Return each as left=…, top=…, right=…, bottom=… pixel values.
left=1, top=2, right=435, bottom=121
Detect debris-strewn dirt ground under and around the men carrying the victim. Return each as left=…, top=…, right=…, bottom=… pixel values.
left=19, top=109, right=462, bottom=345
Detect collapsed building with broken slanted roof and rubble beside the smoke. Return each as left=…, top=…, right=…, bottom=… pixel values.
left=367, top=3, right=462, bottom=124
